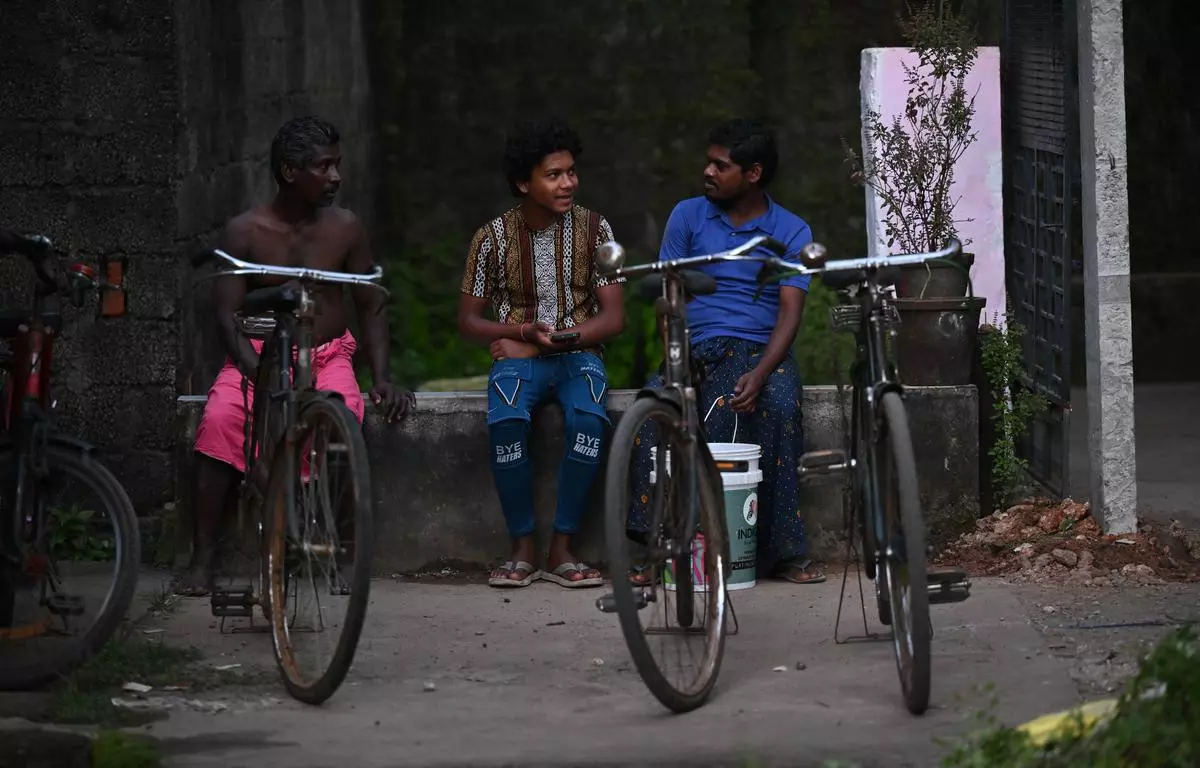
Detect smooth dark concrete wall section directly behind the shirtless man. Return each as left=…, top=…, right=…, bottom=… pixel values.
left=174, top=0, right=374, bottom=403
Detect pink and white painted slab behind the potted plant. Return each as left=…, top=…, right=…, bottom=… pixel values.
left=860, top=47, right=1006, bottom=320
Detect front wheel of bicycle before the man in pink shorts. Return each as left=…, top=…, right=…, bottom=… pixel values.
left=264, top=392, right=373, bottom=704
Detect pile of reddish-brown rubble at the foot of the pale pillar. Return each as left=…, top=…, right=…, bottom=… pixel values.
left=935, top=498, right=1200, bottom=587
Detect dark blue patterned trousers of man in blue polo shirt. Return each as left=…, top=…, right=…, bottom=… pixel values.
left=626, top=337, right=808, bottom=576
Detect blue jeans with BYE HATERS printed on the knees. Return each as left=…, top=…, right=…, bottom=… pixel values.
left=487, top=352, right=610, bottom=539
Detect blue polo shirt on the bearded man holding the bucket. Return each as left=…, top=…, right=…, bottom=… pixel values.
left=659, top=196, right=812, bottom=344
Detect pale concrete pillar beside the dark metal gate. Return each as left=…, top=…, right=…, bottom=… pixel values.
left=1078, top=0, right=1138, bottom=533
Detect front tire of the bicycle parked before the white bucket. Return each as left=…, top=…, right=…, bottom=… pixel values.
left=605, top=397, right=730, bottom=714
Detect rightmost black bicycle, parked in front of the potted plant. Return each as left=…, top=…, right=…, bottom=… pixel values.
left=781, top=240, right=971, bottom=714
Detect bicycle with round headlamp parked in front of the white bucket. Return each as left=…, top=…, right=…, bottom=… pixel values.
left=596, top=236, right=794, bottom=713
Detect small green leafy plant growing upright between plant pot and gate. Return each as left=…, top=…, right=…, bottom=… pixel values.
left=979, top=312, right=1049, bottom=506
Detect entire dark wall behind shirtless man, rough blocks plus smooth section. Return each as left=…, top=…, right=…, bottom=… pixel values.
left=0, top=0, right=373, bottom=515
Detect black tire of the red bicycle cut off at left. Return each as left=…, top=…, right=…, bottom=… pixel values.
left=0, top=443, right=142, bottom=691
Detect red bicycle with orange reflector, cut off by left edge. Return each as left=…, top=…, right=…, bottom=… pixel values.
left=0, top=235, right=142, bottom=690
